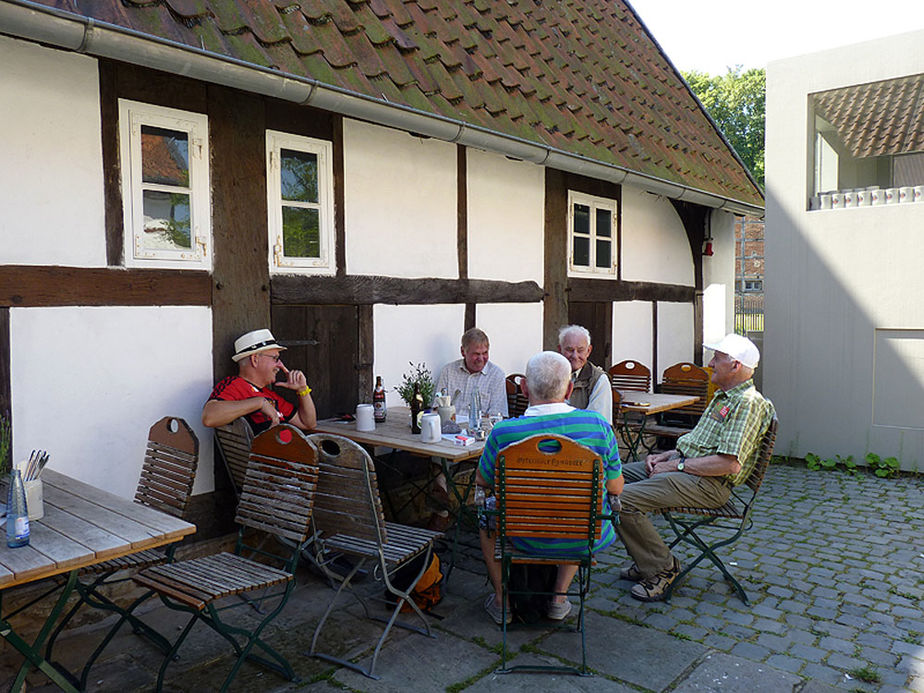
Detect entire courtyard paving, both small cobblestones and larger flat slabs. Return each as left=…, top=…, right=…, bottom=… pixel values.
left=0, top=465, right=924, bottom=693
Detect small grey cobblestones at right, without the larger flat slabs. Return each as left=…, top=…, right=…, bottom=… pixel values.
left=592, top=465, right=924, bottom=693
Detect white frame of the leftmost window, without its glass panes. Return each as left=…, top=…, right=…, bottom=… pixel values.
left=119, top=99, right=212, bottom=269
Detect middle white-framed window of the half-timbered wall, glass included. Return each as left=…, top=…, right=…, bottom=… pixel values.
left=266, top=130, right=336, bottom=274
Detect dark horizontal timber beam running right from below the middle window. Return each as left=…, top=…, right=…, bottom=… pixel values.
left=271, top=274, right=543, bottom=305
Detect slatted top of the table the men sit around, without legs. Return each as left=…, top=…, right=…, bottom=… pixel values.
left=315, top=407, right=484, bottom=462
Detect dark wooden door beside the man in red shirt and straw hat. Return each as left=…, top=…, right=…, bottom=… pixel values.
left=272, top=305, right=364, bottom=419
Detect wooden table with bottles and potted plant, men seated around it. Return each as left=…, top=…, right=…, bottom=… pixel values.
left=315, top=407, right=484, bottom=582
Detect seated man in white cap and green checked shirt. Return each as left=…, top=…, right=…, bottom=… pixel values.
left=617, top=334, right=774, bottom=602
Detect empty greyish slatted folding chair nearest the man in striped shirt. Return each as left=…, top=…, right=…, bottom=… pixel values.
left=309, top=433, right=442, bottom=679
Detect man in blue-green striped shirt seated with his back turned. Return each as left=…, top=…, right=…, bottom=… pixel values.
left=475, top=351, right=623, bottom=624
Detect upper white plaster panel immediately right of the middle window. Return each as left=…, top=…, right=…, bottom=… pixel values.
left=343, top=119, right=459, bottom=278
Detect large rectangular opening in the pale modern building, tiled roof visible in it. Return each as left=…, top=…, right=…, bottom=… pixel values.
left=809, top=75, right=924, bottom=209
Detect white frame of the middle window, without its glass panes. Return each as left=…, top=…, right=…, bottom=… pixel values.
left=266, top=130, right=336, bottom=275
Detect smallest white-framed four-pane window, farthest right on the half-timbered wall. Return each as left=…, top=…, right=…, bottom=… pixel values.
left=568, top=191, right=616, bottom=275
